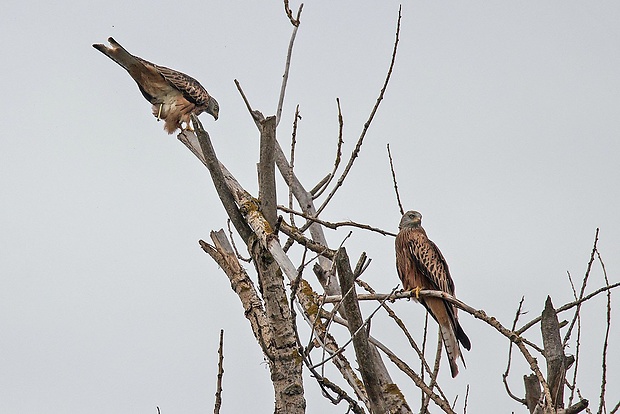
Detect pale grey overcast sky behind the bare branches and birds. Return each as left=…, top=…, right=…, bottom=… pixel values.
left=0, top=0, right=620, bottom=414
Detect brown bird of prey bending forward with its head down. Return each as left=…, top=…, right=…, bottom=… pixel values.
left=93, top=37, right=220, bottom=134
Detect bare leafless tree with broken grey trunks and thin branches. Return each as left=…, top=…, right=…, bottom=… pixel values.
left=100, top=1, right=620, bottom=414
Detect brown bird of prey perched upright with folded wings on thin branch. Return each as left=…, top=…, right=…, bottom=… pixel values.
left=396, top=211, right=471, bottom=378
